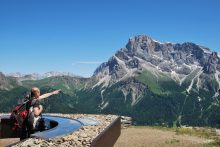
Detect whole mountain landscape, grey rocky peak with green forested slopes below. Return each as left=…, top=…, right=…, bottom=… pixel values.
left=0, top=35, right=220, bottom=127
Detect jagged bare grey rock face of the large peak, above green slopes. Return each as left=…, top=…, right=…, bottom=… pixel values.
left=94, top=35, right=220, bottom=89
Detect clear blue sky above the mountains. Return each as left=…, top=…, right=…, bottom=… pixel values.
left=0, top=0, right=220, bottom=76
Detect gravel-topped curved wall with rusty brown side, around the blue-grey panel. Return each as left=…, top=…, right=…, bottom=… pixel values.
left=0, top=114, right=120, bottom=147
